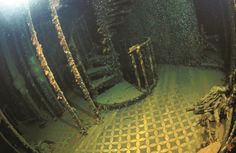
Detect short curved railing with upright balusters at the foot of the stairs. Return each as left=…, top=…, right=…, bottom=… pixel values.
left=128, top=38, right=157, bottom=91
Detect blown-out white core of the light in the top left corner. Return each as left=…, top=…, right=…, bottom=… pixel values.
left=0, top=0, right=26, bottom=8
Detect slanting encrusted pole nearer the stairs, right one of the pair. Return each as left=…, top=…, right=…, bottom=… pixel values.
left=49, top=0, right=100, bottom=120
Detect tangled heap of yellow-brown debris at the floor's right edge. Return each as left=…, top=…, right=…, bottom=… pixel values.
left=187, top=70, right=236, bottom=153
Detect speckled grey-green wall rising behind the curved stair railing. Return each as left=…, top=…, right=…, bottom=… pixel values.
left=118, top=0, right=201, bottom=65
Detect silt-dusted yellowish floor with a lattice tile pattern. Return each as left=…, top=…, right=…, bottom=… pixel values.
left=20, top=65, right=223, bottom=153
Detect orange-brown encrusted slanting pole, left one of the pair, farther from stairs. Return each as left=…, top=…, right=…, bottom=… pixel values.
left=26, top=3, right=87, bottom=134
